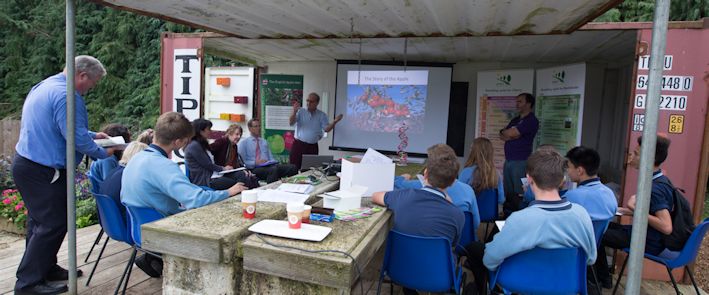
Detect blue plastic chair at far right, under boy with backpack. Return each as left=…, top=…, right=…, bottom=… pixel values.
left=613, top=218, right=709, bottom=295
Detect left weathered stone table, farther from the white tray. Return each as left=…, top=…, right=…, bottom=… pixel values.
left=142, top=172, right=339, bottom=294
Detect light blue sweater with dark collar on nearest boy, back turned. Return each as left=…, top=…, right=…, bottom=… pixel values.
left=483, top=200, right=596, bottom=270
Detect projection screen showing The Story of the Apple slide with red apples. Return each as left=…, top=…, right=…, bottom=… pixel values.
left=333, top=64, right=452, bottom=154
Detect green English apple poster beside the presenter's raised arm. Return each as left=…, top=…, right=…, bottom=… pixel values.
left=261, top=74, right=303, bottom=163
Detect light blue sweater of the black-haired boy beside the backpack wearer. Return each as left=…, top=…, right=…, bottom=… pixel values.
left=564, top=178, right=618, bottom=220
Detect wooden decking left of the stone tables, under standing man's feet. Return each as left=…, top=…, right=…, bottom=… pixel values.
left=0, top=225, right=162, bottom=294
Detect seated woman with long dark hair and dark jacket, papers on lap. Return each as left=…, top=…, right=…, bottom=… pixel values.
left=185, top=118, right=258, bottom=190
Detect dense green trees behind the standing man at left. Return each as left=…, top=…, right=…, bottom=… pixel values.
left=0, top=0, right=199, bottom=131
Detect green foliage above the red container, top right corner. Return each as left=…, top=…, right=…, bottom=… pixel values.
left=595, top=0, right=709, bottom=22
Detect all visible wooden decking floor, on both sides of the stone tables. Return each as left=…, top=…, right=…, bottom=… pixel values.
left=0, top=225, right=707, bottom=294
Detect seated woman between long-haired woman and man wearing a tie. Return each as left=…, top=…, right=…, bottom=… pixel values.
left=209, top=124, right=259, bottom=188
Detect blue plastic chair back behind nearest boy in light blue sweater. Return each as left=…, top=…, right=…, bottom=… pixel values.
left=490, top=248, right=586, bottom=295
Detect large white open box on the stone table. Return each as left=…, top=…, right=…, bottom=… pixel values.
left=340, top=159, right=395, bottom=197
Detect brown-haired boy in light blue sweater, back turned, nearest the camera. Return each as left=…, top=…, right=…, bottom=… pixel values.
left=466, top=150, right=596, bottom=294
